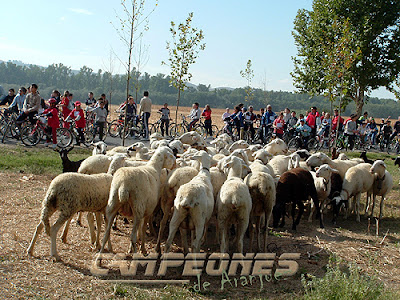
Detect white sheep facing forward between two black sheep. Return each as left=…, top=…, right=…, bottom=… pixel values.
left=308, top=164, right=338, bottom=222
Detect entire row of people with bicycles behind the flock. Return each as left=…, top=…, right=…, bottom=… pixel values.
left=0, top=84, right=400, bottom=149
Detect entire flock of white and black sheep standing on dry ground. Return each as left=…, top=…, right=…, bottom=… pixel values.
left=27, top=132, right=393, bottom=259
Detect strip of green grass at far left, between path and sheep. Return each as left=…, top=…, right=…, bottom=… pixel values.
left=0, top=146, right=91, bottom=175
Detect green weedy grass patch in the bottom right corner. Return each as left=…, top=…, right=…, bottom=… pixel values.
left=302, top=255, right=399, bottom=300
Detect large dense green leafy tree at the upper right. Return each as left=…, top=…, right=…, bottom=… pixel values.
left=292, top=0, right=400, bottom=115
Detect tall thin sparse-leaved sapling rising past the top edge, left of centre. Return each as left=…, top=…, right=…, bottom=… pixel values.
left=114, top=0, right=158, bottom=145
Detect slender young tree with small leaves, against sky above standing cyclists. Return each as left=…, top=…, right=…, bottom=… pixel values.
left=162, top=12, right=206, bottom=123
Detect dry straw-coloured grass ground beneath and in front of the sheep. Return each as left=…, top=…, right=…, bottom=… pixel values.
left=0, top=143, right=400, bottom=299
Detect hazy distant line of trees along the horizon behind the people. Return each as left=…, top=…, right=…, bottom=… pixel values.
left=0, top=62, right=400, bottom=118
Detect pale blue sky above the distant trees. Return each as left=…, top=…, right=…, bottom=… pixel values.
left=0, top=0, right=394, bottom=99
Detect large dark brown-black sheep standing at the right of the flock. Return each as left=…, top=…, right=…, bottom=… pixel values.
left=272, top=168, right=324, bottom=230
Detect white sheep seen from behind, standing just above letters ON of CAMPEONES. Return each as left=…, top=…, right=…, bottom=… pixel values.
left=216, top=156, right=252, bottom=253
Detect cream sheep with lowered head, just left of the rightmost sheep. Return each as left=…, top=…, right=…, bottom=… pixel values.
left=332, top=163, right=374, bottom=222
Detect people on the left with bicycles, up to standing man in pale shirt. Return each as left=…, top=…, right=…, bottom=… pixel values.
left=0, top=84, right=152, bottom=148
